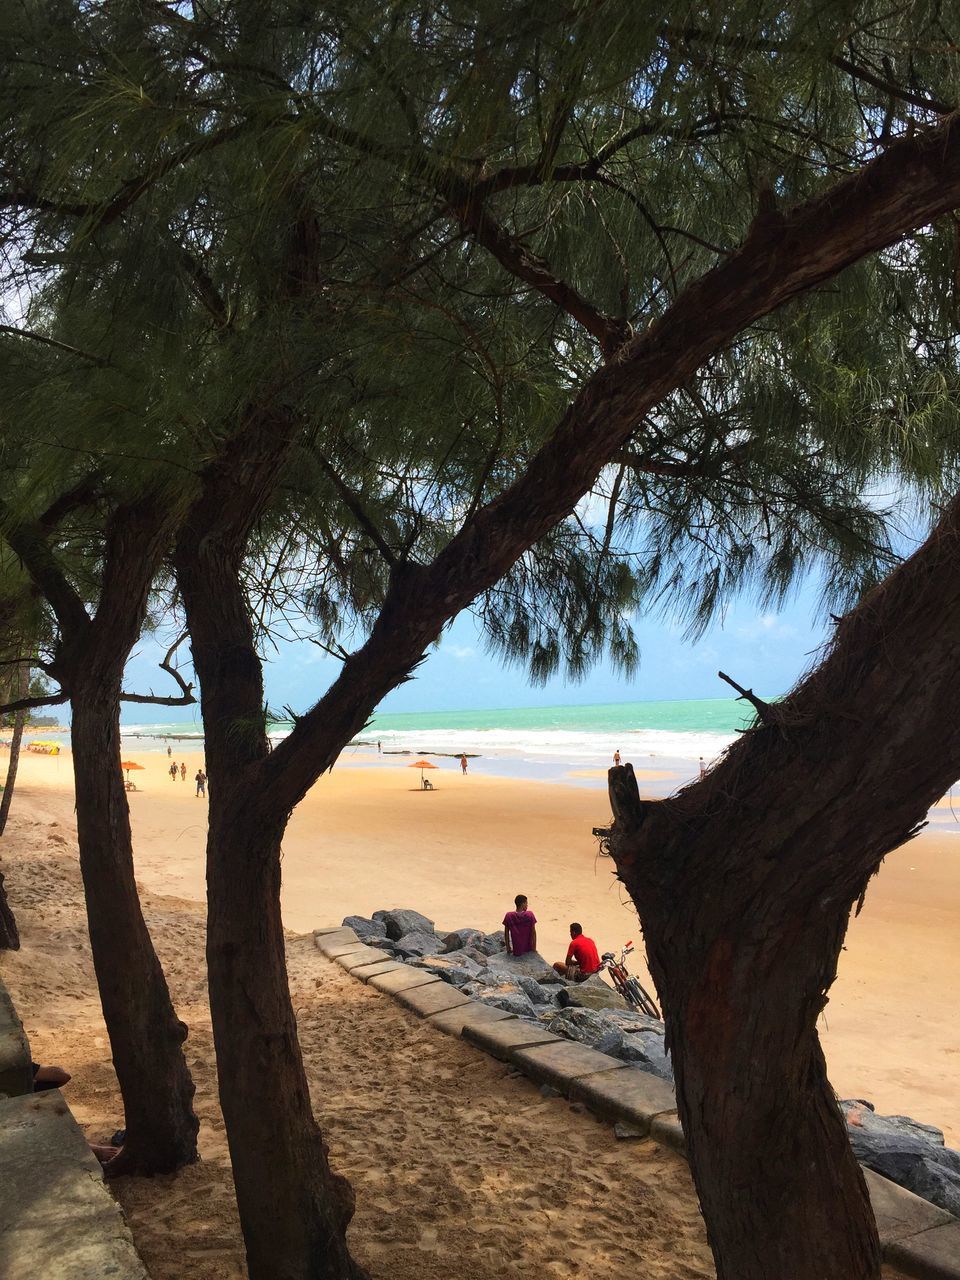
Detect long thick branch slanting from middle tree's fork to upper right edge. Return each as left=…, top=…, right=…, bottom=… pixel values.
left=262, top=116, right=960, bottom=809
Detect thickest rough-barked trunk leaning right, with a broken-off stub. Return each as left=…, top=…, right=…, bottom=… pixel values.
left=611, top=491, right=960, bottom=1280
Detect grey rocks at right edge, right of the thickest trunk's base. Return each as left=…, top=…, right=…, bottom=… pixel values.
left=840, top=1100, right=960, bottom=1215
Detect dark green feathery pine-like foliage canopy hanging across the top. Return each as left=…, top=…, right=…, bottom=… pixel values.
left=0, top=0, right=960, bottom=677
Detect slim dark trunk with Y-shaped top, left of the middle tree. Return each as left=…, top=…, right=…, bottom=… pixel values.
left=4, top=494, right=198, bottom=1176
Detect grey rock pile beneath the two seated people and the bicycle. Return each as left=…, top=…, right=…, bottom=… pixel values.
left=343, top=909, right=673, bottom=1083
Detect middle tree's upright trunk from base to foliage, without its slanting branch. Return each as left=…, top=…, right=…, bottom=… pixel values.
left=175, top=419, right=365, bottom=1280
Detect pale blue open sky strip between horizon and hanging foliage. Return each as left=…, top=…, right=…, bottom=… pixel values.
left=122, top=582, right=832, bottom=724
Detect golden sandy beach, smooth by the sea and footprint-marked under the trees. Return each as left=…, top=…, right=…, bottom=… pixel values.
left=0, top=751, right=960, bottom=1280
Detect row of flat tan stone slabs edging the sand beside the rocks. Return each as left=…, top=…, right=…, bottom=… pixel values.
left=314, top=925, right=960, bottom=1280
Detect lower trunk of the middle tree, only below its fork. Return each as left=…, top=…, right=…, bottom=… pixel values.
left=207, top=783, right=364, bottom=1280
